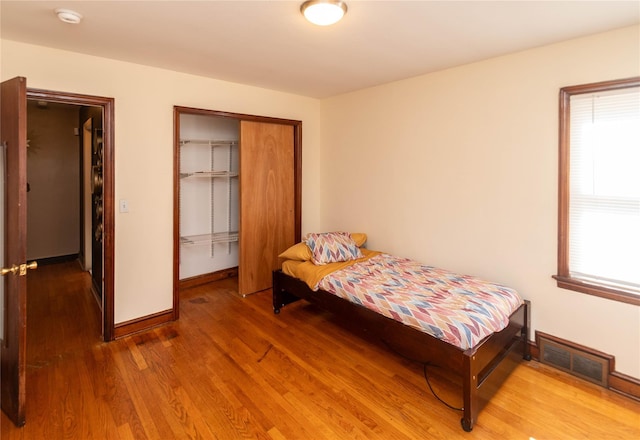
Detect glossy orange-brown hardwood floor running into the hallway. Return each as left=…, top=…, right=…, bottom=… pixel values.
left=0, top=262, right=640, bottom=440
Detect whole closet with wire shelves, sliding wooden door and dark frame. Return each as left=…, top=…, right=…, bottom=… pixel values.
left=173, top=106, right=302, bottom=312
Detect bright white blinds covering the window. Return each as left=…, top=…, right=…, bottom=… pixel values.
left=568, top=87, right=640, bottom=294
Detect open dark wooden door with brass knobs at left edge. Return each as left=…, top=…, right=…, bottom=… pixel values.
left=0, top=77, right=35, bottom=426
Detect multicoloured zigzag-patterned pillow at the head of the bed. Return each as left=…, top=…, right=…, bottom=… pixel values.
left=304, top=232, right=363, bottom=265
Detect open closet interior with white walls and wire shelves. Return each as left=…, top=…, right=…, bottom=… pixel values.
left=179, top=113, right=240, bottom=288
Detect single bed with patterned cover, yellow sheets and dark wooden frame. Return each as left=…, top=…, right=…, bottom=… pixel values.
left=273, top=232, right=530, bottom=432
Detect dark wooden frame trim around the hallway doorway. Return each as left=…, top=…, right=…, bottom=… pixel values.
left=27, top=87, right=115, bottom=342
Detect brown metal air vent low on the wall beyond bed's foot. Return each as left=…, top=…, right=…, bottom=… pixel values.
left=536, top=332, right=613, bottom=387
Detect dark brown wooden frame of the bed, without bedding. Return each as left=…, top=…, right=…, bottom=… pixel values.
left=273, top=270, right=531, bottom=432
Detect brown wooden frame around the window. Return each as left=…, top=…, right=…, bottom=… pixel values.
left=553, top=77, right=640, bottom=305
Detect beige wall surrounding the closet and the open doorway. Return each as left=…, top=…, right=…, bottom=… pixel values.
left=0, top=40, right=320, bottom=323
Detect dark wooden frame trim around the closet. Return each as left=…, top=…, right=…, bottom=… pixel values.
left=173, top=105, right=302, bottom=314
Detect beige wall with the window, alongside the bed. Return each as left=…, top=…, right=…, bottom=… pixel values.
left=321, top=27, right=640, bottom=377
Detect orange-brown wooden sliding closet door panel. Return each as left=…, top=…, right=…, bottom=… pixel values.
left=238, top=121, right=295, bottom=295
